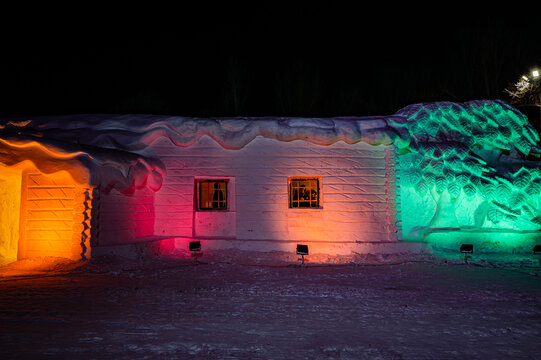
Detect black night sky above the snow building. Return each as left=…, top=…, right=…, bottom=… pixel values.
left=0, top=5, right=541, bottom=116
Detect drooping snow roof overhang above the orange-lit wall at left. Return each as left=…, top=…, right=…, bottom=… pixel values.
left=0, top=120, right=165, bottom=194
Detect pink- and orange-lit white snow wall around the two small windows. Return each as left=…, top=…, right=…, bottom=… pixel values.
left=151, top=137, right=397, bottom=242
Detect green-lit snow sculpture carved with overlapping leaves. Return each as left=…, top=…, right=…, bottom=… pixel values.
left=396, top=101, right=541, bottom=238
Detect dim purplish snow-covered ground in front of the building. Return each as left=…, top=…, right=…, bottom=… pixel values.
left=0, top=256, right=541, bottom=359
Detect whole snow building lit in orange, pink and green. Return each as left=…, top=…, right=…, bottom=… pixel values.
left=0, top=100, right=541, bottom=263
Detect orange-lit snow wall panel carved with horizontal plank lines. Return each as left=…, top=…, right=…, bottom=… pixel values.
left=18, top=171, right=91, bottom=260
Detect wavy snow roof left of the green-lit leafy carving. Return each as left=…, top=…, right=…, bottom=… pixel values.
left=0, top=114, right=409, bottom=194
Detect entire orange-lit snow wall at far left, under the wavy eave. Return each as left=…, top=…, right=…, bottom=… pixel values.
left=0, top=158, right=92, bottom=265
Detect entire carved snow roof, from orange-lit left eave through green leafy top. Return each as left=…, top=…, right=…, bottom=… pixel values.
left=0, top=100, right=539, bottom=192
